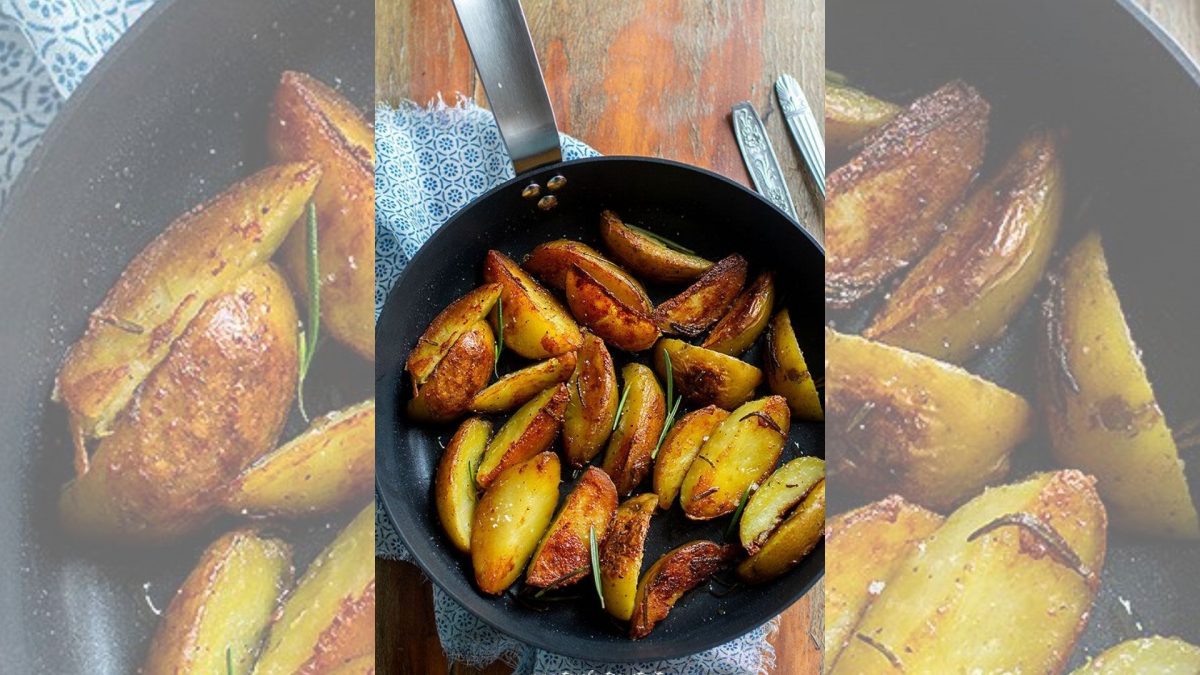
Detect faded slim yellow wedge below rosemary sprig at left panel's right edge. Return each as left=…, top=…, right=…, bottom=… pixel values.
left=224, top=399, right=374, bottom=518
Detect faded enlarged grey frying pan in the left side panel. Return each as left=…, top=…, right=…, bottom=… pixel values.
left=0, top=0, right=373, bottom=674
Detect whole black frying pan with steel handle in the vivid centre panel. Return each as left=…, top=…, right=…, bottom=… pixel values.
left=376, top=0, right=824, bottom=662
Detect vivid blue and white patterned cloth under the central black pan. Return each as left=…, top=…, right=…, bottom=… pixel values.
left=376, top=100, right=776, bottom=675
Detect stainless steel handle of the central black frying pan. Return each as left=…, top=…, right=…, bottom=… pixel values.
left=454, top=0, right=563, bottom=173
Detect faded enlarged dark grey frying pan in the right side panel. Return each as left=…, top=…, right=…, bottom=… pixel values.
left=827, top=0, right=1200, bottom=667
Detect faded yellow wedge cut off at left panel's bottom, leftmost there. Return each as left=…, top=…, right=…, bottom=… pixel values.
left=140, top=530, right=293, bottom=675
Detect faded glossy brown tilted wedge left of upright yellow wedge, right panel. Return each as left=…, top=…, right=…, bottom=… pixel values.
left=863, top=131, right=1063, bottom=363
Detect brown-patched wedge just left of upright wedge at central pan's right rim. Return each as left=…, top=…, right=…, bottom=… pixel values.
left=654, top=338, right=762, bottom=410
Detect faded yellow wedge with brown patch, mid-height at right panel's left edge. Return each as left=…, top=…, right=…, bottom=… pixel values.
left=826, top=329, right=1033, bottom=509
